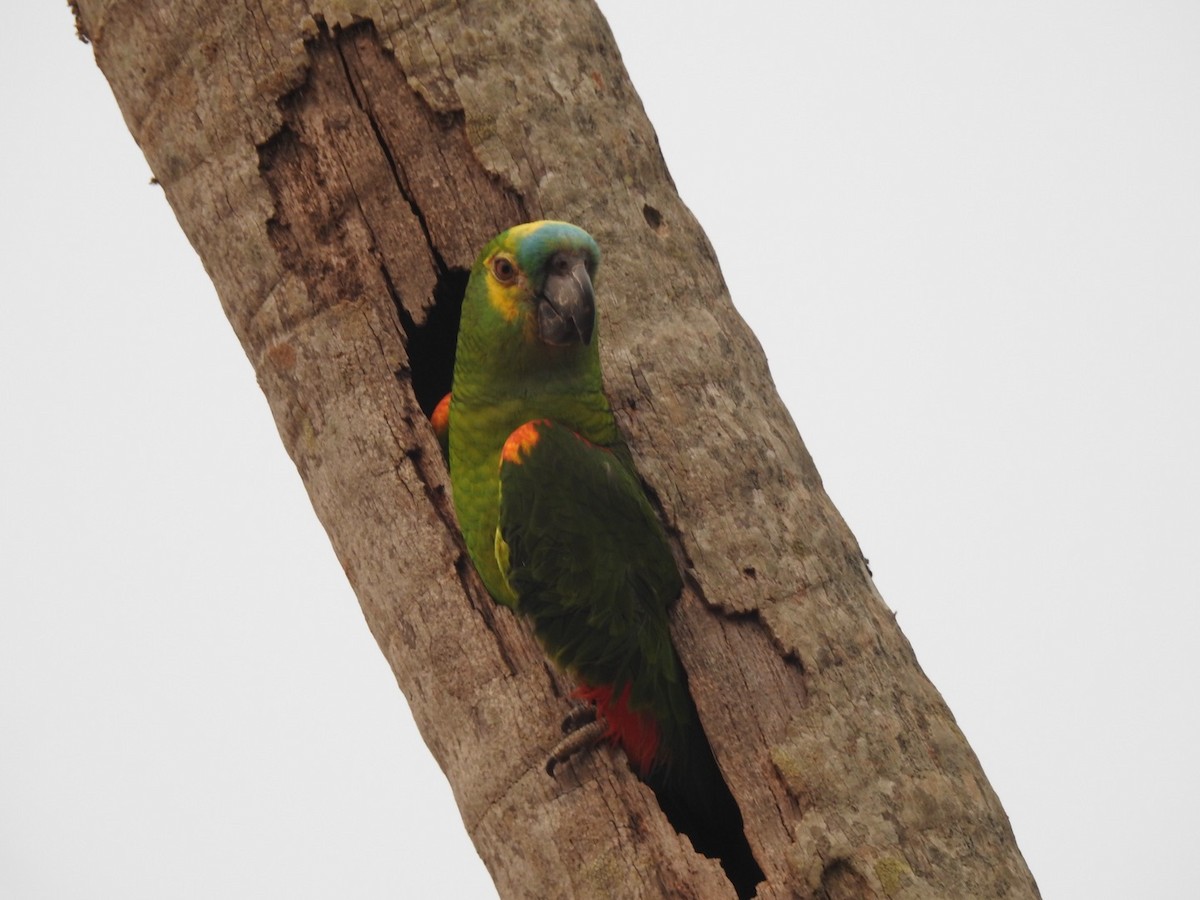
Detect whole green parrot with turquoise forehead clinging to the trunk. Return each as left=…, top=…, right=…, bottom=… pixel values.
left=433, top=222, right=762, bottom=895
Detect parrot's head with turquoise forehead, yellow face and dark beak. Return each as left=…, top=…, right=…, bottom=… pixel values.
left=456, top=222, right=600, bottom=393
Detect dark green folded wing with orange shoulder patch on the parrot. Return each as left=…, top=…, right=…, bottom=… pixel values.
left=496, top=419, right=691, bottom=763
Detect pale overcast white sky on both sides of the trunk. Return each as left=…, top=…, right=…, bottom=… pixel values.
left=0, top=0, right=1200, bottom=899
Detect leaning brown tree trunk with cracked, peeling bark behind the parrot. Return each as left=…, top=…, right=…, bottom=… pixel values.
left=70, top=0, right=1038, bottom=898
